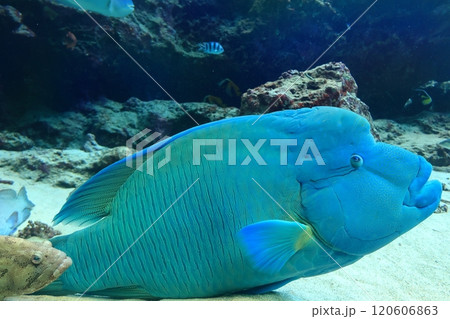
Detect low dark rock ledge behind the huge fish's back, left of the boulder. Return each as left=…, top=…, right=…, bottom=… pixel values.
left=16, top=98, right=239, bottom=151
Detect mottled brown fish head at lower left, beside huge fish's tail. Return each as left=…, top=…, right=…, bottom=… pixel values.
left=0, top=236, right=72, bottom=300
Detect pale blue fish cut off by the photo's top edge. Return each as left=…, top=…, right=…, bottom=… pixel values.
left=48, top=0, right=134, bottom=18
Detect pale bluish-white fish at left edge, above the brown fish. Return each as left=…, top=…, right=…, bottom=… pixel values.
left=0, top=187, right=34, bottom=235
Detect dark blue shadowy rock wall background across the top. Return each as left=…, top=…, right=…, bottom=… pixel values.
left=0, top=0, right=450, bottom=118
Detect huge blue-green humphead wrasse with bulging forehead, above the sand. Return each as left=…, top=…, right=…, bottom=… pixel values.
left=40, top=107, right=442, bottom=299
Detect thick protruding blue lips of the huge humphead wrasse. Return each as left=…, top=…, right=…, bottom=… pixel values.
left=403, top=156, right=442, bottom=214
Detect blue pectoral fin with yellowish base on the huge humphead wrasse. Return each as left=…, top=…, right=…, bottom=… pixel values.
left=239, top=220, right=313, bottom=273
